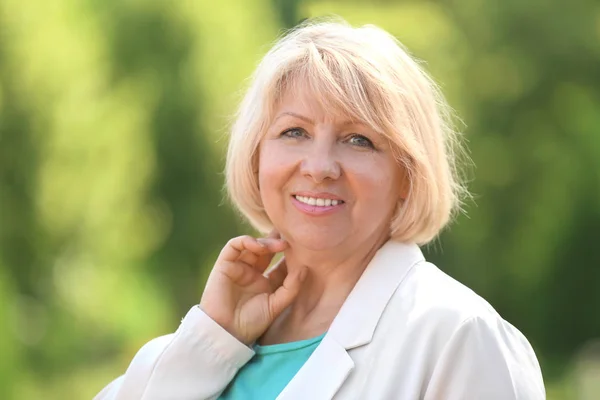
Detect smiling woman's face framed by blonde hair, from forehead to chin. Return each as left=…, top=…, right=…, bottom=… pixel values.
left=258, top=86, right=406, bottom=251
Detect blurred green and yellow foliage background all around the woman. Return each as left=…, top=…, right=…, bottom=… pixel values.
left=0, top=0, right=600, bottom=400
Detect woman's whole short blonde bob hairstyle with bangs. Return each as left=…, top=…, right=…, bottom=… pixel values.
left=225, top=20, right=467, bottom=244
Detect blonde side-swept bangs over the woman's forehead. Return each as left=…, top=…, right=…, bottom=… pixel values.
left=270, top=45, right=391, bottom=134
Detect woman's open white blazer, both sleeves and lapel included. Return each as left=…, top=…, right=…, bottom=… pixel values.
left=95, top=241, right=546, bottom=400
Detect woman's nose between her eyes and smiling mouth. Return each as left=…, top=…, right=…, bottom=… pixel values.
left=300, top=140, right=341, bottom=183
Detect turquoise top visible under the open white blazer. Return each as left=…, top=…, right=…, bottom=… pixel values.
left=219, top=334, right=325, bottom=400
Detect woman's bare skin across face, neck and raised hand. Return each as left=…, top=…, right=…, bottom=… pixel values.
left=200, top=85, right=407, bottom=345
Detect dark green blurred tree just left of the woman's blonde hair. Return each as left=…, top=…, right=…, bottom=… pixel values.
left=97, top=1, right=238, bottom=313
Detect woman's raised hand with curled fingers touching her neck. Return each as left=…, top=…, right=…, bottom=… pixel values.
left=200, top=232, right=307, bottom=345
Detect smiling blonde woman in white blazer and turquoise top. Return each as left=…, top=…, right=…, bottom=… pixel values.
left=96, top=18, right=545, bottom=400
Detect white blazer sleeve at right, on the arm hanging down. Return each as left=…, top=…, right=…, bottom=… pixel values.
left=424, top=317, right=546, bottom=400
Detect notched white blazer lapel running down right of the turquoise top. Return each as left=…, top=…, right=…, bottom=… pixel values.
left=277, top=241, right=424, bottom=400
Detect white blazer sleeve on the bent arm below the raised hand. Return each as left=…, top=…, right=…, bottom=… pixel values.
left=94, top=306, right=254, bottom=400
